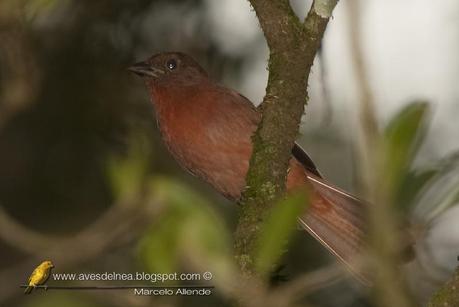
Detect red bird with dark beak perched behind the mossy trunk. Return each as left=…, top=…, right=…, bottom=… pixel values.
left=130, top=53, right=365, bottom=280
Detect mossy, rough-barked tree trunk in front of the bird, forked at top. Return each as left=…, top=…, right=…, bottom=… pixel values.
left=235, top=0, right=336, bottom=276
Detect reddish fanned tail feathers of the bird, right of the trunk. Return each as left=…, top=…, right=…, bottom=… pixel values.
left=299, top=174, right=368, bottom=283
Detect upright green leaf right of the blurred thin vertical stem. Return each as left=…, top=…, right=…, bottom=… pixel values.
left=380, top=102, right=429, bottom=195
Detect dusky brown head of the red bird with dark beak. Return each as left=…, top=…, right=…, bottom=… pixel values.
left=129, top=52, right=207, bottom=89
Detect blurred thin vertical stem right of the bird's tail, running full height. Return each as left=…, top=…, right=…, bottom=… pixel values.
left=347, top=0, right=411, bottom=307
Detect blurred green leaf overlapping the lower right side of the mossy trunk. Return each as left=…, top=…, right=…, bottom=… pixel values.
left=254, top=190, right=308, bottom=274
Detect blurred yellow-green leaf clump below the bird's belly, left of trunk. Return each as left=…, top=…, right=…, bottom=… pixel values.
left=139, top=178, right=232, bottom=277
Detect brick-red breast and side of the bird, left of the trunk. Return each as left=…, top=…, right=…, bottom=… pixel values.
left=157, top=92, right=254, bottom=199
